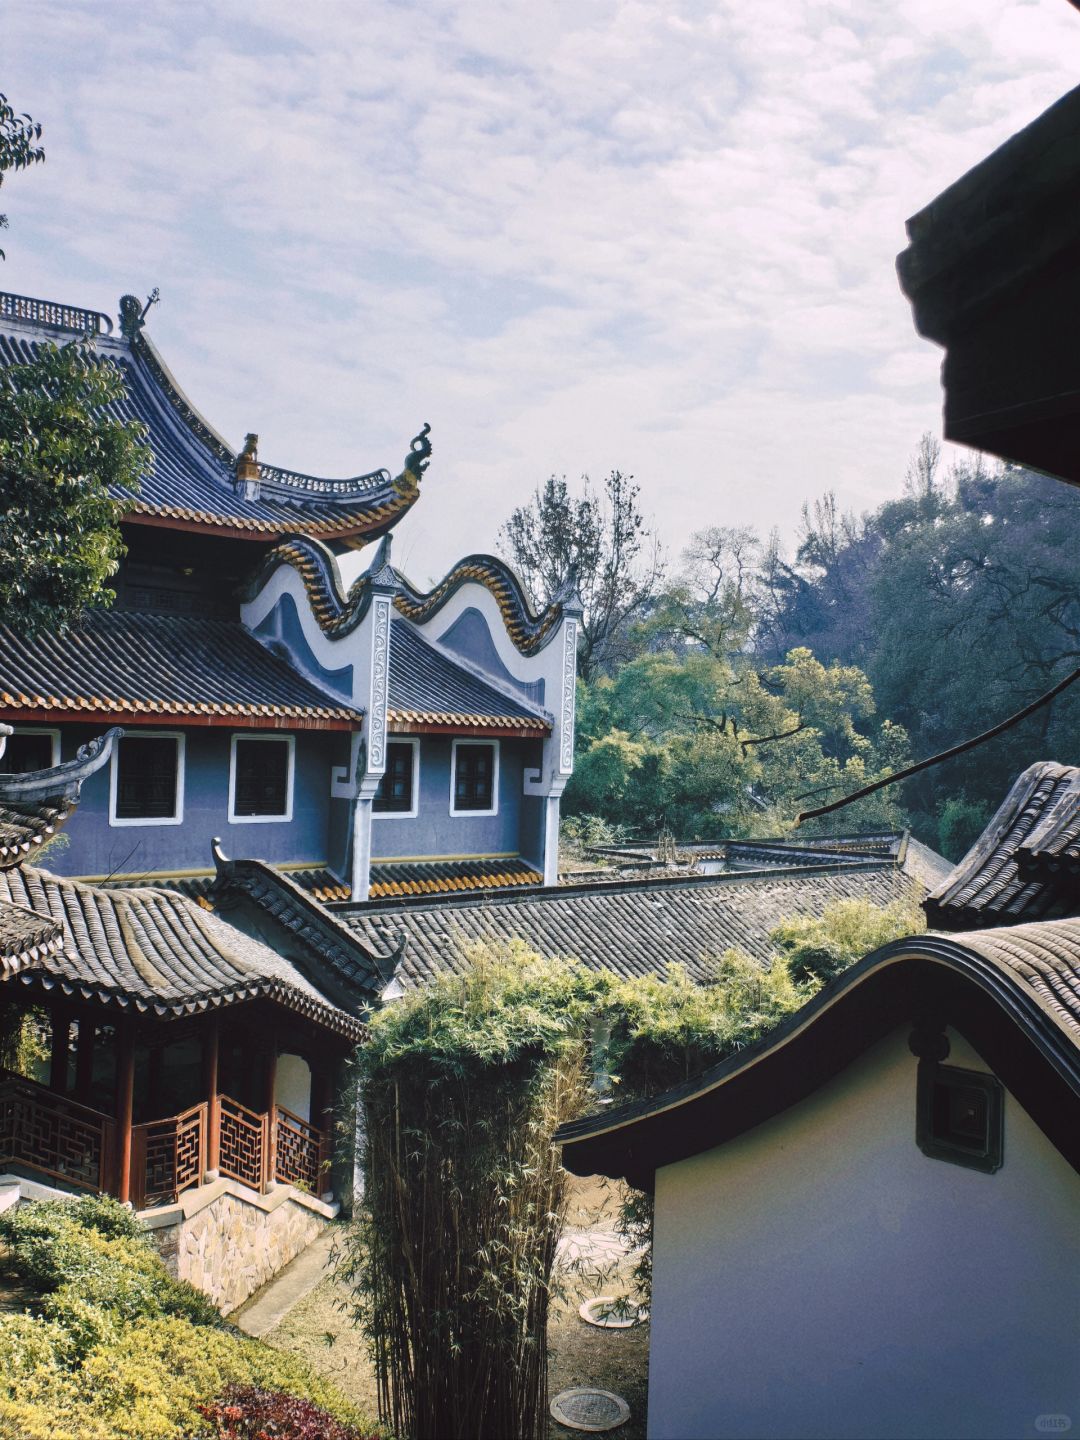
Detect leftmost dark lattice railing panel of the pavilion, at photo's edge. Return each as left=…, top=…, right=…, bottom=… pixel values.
left=0, top=1071, right=115, bottom=1189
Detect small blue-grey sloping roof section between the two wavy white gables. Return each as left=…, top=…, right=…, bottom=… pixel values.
left=387, top=622, right=552, bottom=734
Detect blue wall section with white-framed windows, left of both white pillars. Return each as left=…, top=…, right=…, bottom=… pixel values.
left=43, top=726, right=348, bottom=876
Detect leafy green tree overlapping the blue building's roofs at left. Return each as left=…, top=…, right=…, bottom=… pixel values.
left=0, top=341, right=148, bottom=629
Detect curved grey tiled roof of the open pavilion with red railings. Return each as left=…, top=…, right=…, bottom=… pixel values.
left=0, top=865, right=363, bottom=1038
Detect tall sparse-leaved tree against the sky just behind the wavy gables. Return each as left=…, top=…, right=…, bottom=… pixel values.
left=498, top=469, right=664, bottom=680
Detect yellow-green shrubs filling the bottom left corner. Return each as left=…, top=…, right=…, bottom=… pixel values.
left=0, top=1198, right=377, bottom=1440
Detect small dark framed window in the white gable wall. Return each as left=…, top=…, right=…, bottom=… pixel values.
left=916, top=1060, right=1002, bottom=1172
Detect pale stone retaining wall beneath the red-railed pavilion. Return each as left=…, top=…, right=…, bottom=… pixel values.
left=140, top=1179, right=338, bottom=1315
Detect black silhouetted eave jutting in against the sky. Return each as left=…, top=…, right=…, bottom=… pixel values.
left=897, top=88, right=1080, bottom=485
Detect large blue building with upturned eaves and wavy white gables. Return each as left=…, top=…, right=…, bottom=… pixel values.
left=0, top=295, right=580, bottom=901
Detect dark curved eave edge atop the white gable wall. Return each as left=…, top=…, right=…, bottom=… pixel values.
left=556, top=936, right=1080, bottom=1189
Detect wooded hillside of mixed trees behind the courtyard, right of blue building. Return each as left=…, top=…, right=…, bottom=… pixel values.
left=500, top=435, right=1080, bottom=860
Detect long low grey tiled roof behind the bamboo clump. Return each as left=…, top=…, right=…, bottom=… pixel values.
left=337, top=861, right=924, bottom=986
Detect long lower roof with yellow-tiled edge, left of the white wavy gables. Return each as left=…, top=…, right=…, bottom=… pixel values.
left=0, top=611, right=361, bottom=729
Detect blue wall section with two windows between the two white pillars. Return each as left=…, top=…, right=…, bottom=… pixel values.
left=372, top=736, right=540, bottom=860
